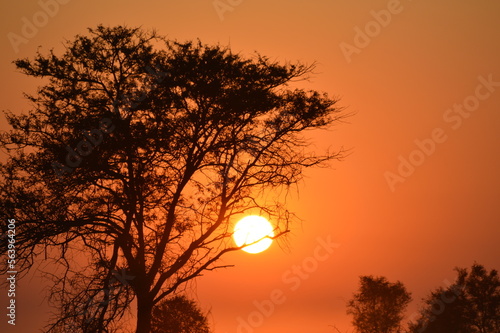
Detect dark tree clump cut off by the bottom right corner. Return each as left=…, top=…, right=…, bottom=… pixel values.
left=409, top=264, right=500, bottom=333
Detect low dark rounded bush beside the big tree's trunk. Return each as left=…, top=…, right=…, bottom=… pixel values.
left=151, top=296, right=210, bottom=333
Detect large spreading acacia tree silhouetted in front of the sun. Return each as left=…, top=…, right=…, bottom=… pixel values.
left=0, top=26, right=343, bottom=333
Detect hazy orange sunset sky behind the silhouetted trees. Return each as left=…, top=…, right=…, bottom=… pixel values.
left=0, top=0, right=500, bottom=333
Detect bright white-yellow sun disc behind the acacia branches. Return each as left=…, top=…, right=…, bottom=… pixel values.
left=233, top=215, right=274, bottom=253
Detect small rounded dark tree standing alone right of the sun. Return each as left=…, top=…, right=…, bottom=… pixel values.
left=347, top=276, right=411, bottom=333
